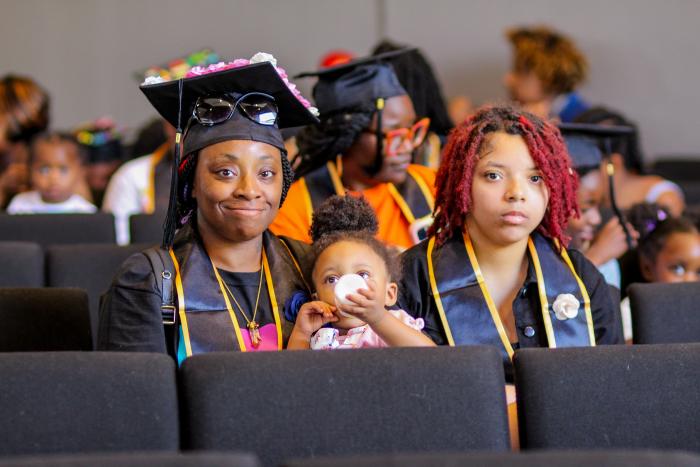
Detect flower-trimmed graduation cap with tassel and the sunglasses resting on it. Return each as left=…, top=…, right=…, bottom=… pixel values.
left=141, top=53, right=318, bottom=248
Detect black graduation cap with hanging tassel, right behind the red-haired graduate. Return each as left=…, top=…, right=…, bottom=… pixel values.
left=559, top=123, right=636, bottom=250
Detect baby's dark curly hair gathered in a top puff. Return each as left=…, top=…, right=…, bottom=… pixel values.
left=309, top=195, right=399, bottom=281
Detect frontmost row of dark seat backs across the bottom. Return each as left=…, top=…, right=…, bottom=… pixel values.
left=0, top=344, right=700, bottom=466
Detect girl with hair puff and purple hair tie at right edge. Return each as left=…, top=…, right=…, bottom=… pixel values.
left=620, top=203, right=700, bottom=342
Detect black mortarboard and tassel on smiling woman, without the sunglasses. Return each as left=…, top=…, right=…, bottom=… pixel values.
left=141, top=57, right=318, bottom=249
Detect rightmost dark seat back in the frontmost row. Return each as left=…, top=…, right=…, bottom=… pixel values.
left=514, top=344, right=700, bottom=451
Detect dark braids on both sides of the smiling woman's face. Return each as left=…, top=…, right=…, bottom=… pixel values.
left=177, top=145, right=294, bottom=228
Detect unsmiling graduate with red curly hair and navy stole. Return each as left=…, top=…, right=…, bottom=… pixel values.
left=399, top=107, right=621, bottom=377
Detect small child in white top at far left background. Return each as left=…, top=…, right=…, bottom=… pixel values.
left=7, top=133, right=97, bottom=214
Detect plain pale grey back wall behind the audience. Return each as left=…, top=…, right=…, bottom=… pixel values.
left=0, top=0, right=700, bottom=163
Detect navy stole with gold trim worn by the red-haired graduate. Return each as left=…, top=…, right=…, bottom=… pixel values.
left=426, top=232, right=595, bottom=358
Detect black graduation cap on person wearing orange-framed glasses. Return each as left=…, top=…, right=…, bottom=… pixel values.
left=296, top=48, right=414, bottom=115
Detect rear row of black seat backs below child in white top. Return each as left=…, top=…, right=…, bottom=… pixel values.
left=0, top=212, right=163, bottom=246
